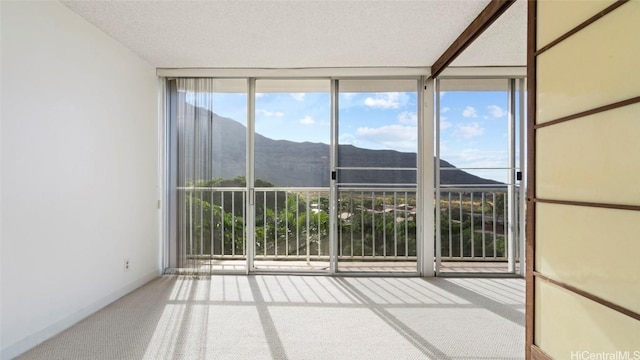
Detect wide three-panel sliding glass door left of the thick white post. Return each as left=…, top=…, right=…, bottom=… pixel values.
left=167, top=78, right=419, bottom=274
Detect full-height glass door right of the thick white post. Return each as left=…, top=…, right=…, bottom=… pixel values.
left=436, top=78, right=524, bottom=274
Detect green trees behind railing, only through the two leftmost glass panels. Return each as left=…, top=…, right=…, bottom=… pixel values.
left=181, top=177, right=329, bottom=256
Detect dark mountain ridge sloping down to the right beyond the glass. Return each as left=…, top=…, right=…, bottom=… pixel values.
left=181, top=108, right=501, bottom=187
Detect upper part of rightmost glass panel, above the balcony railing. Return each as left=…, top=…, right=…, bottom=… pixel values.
left=439, top=79, right=509, bottom=184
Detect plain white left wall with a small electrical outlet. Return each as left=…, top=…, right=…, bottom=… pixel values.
left=0, top=1, right=161, bottom=359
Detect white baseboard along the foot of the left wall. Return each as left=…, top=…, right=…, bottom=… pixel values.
left=0, top=270, right=162, bottom=360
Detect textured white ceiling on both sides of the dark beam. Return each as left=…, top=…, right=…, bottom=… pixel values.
left=63, top=0, right=526, bottom=68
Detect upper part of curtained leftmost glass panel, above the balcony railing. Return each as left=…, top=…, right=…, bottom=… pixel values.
left=177, top=79, right=247, bottom=186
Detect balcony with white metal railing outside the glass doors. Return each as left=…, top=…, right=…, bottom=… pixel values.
left=171, top=187, right=519, bottom=274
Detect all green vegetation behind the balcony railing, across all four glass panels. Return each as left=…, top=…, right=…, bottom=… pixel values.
left=178, top=177, right=505, bottom=260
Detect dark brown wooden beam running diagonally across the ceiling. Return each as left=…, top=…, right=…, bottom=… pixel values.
left=430, top=0, right=515, bottom=78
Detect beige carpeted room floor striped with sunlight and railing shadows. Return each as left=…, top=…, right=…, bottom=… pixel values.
left=18, top=275, right=525, bottom=360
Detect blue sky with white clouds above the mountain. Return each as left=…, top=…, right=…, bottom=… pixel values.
left=198, top=87, right=508, bottom=181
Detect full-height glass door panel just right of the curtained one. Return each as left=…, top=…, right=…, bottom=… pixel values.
left=252, top=79, right=332, bottom=271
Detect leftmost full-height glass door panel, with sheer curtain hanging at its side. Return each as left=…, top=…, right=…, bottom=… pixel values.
left=167, top=79, right=247, bottom=274
